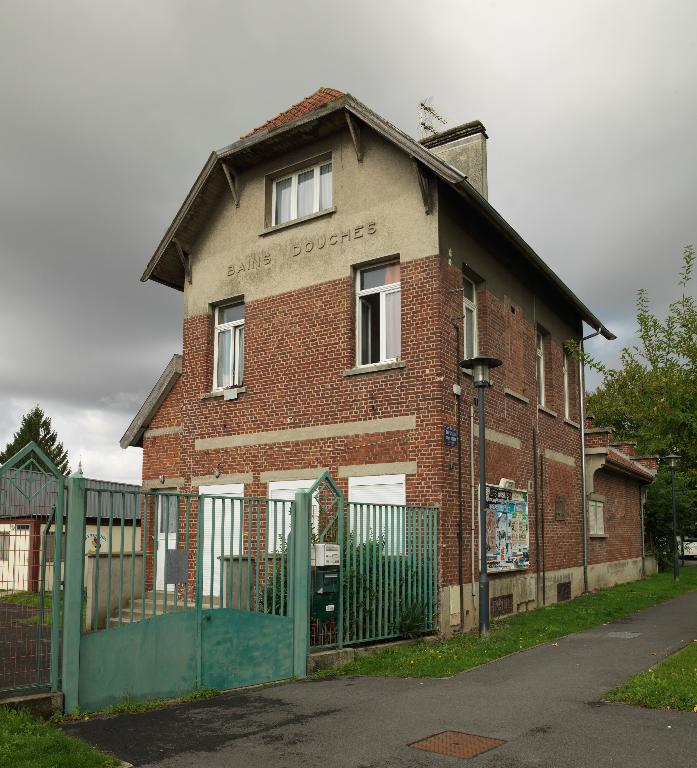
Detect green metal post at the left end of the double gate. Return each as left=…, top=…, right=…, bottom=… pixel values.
left=63, top=474, right=86, bottom=712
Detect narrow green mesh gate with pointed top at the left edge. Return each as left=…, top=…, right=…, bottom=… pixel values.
left=0, top=443, right=65, bottom=697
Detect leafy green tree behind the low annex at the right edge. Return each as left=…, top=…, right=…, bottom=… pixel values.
left=585, top=245, right=697, bottom=559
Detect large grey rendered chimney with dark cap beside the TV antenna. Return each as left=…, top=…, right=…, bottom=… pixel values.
left=421, top=120, right=489, bottom=198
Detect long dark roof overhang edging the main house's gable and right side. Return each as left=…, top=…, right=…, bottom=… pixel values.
left=141, top=94, right=616, bottom=340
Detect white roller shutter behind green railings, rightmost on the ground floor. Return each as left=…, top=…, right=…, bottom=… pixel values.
left=349, top=475, right=407, bottom=554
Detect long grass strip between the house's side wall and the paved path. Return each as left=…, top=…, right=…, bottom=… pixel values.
left=312, top=568, right=697, bottom=679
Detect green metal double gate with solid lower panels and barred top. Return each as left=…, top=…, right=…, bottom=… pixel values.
left=63, top=478, right=310, bottom=711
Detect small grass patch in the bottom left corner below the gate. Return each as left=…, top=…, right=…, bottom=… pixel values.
left=0, top=707, right=121, bottom=768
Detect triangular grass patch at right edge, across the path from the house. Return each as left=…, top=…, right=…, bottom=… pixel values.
left=605, top=640, right=697, bottom=712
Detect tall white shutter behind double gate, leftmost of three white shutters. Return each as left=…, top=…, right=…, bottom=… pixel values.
left=198, top=483, right=244, bottom=604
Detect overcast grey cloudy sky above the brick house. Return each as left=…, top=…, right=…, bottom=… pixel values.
left=0, top=0, right=697, bottom=482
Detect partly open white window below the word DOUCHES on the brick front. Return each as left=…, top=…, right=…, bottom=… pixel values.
left=357, top=262, right=402, bottom=365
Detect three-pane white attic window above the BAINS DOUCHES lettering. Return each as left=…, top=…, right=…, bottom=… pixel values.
left=271, top=160, right=332, bottom=227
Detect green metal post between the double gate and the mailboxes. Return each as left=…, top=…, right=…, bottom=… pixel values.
left=290, top=491, right=312, bottom=677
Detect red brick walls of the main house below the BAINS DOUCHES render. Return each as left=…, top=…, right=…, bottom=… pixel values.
left=143, top=249, right=640, bottom=586
